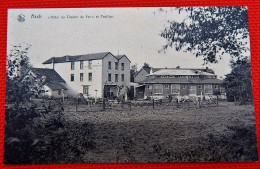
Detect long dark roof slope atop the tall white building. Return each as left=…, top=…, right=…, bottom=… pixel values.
left=42, top=52, right=110, bottom=64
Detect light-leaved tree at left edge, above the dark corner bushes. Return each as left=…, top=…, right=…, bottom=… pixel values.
left=6, top=45, right=45, bottom=108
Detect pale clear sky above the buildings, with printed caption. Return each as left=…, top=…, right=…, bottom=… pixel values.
left=7, top=8, right=250, bottom=77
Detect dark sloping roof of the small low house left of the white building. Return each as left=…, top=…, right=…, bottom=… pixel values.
left=31, top=68, right=66, bottom=90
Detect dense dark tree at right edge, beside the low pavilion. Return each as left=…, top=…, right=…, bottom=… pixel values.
left=223, top=59, right=253, bottom=104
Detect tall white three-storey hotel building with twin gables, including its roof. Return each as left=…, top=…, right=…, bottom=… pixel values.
left=43, top=52, right=130, bottom=98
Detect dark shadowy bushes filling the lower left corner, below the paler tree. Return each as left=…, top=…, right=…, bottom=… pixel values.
left=4, top=100, right=95, bottom=164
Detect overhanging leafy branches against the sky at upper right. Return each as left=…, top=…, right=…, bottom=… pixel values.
left=160, top=7, right=249, bottom=64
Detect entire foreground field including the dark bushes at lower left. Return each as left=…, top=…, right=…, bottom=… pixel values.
left=5, top=102, right=258, bottom=163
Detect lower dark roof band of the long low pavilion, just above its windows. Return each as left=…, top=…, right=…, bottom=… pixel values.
left=140, top=77, right=223, bottom=84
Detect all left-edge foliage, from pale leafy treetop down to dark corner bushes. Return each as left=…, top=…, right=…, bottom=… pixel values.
left=4, top=45, right=95, bottom=164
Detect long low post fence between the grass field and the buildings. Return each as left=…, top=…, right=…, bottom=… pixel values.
left=23, top=97, right=219, bottom=113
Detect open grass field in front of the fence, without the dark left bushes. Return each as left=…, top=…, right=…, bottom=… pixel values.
left=60, top=102, right=257, bottom=162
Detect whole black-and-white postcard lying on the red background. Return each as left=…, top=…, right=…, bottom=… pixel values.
left=4, top=6, right=258, bottom=164
